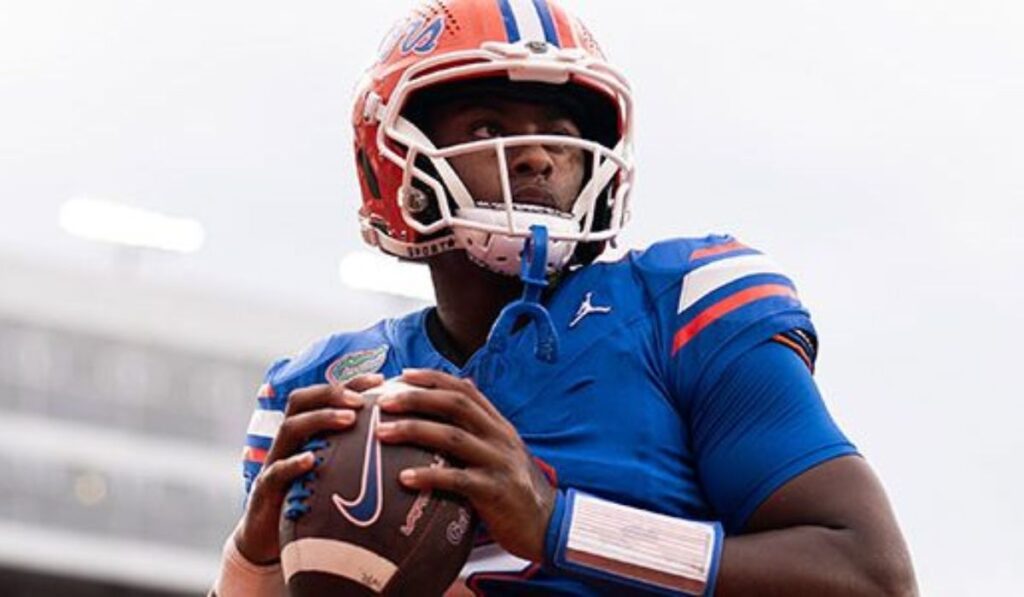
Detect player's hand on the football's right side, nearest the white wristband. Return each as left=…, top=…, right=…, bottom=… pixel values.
left=377, top=370, right=556, bottom=562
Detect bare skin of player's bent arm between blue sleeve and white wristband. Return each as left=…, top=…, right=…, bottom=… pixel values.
left=716, top=456, right=916, bottom=596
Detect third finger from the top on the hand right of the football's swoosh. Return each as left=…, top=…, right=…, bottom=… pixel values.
left=377, top=419, right=501, bottom=466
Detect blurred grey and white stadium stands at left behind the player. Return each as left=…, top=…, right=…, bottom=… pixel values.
left=0, top=250, right=413, bottom=597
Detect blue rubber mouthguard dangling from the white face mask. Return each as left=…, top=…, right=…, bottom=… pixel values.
left=479, top=225, right=558, bottom=385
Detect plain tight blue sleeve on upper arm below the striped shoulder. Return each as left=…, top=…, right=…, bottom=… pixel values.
left=691, top=341, right=856, bottom=534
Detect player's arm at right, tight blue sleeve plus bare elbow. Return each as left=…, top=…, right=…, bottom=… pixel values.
left=695, top=343, right=916, bottom=596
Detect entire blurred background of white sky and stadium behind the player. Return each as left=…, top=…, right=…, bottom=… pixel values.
left=0, top=0, right=1024, bottom=596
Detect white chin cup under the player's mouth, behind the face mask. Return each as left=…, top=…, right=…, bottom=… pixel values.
left=452, top=207, right=580, bottom=275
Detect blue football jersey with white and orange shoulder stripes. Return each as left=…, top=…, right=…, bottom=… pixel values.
left=244, top=236, right=855, bottom=595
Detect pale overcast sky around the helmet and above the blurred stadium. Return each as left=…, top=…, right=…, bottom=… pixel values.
left=0, top=0, right=1024, bottom=595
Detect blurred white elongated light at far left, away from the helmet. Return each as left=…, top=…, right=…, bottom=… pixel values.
left=59, top=197, right=206, bottom=253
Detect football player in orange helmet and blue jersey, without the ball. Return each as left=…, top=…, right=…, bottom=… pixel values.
left=216, top=0, right=915, bottom=597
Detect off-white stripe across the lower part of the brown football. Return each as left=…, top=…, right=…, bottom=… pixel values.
left=281, top=538, right=398, bottom=593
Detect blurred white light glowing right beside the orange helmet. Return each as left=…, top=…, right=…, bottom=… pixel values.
left=338, top=251, right=434, bottom=302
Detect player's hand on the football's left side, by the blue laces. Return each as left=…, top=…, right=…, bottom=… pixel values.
left=234, top=375, right=384, bottom=565
